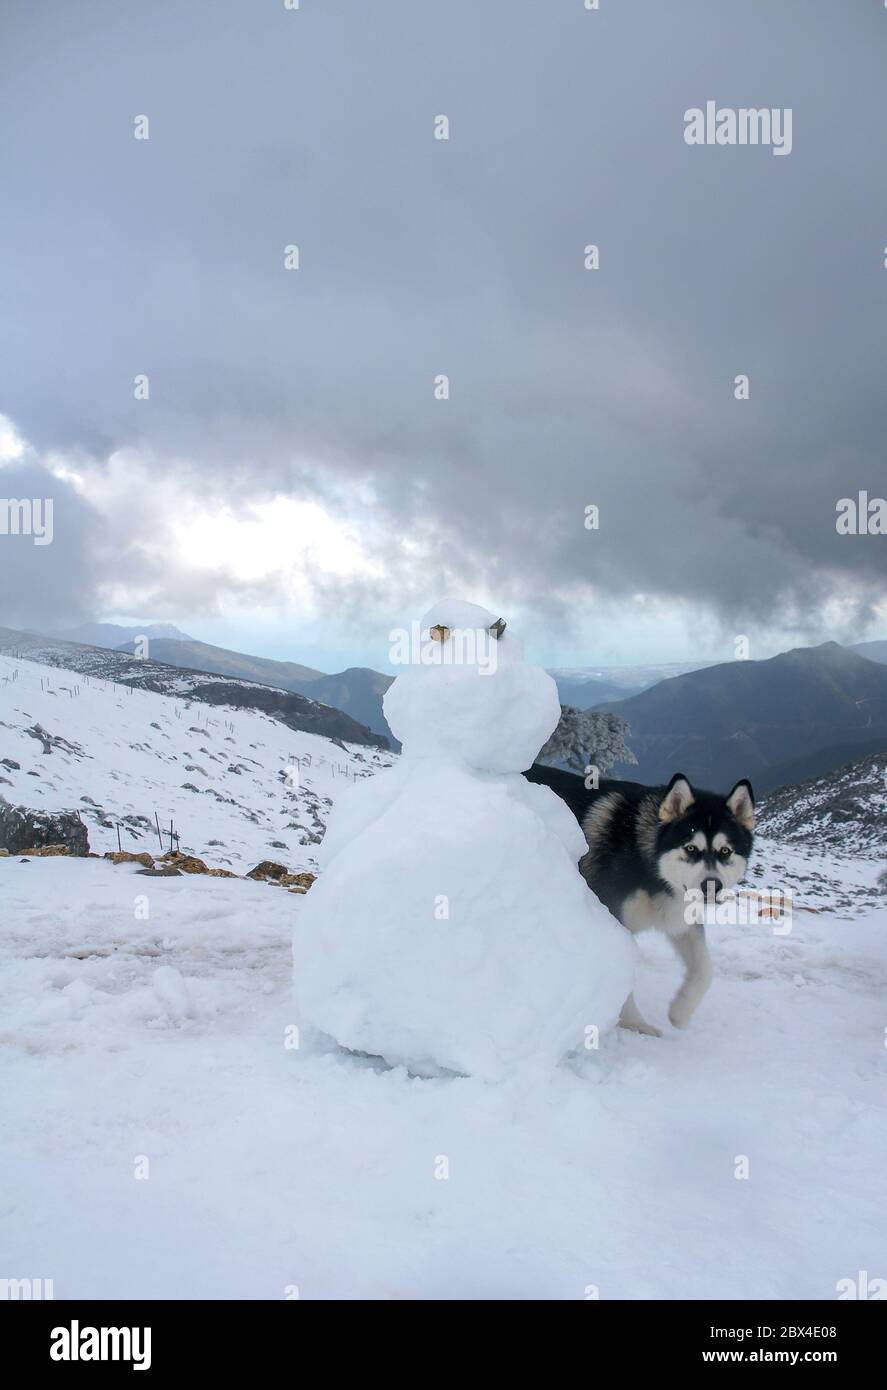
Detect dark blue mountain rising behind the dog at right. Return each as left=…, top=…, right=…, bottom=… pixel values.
left=599, top=642, right=887, bottom=794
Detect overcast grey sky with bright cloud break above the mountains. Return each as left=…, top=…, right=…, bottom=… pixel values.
left=0, top=0, right=887, bottom=670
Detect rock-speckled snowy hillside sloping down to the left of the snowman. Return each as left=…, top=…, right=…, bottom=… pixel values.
left=0, top=653, right=395, bottom=872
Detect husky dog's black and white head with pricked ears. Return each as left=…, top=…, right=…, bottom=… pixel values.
left=656, top=773, right=755, bottom=901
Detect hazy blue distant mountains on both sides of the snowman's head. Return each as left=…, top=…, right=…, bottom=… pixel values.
left=19, top=623, right=887, bottom=795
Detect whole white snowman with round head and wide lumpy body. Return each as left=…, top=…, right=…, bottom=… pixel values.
left=293, top=600, right=633, bottom=1080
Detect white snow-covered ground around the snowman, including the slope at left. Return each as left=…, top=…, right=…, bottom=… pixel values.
left=0, top=662, right=887, bottom=1298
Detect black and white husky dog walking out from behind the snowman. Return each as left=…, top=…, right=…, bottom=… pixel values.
left=524, top=763, right=755, bottom=1037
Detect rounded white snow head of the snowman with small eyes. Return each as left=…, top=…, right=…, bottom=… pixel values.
left=384, top=599, right=560, bottom=773
